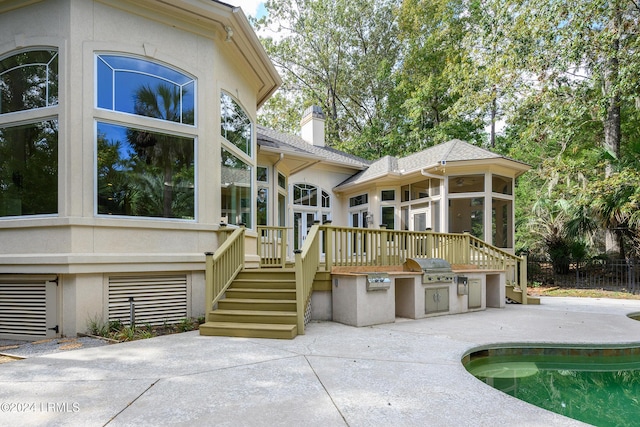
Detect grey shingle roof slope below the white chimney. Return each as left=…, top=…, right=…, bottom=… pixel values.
left=256, top=125, right=371, bottom=169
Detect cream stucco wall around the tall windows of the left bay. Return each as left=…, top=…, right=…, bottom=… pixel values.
left=0, top=0, right=262, bottom=335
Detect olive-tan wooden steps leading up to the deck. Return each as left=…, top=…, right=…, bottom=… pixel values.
left=200, top=268, right=298, bottom=339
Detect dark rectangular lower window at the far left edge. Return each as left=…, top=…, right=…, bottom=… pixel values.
left=0, top=120, right=58, bottom=216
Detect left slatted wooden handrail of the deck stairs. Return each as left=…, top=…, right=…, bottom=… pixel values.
left=205, top=226, right=245, bottom=315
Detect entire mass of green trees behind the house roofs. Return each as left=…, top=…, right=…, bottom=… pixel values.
left=257, top=0, right=640, bottom=263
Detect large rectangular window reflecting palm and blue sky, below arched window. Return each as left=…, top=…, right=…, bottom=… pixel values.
left=97, top=123, right=194, bottom=219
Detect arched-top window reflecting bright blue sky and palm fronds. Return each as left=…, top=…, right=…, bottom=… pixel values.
left=96, top=55, right=195, bottom=125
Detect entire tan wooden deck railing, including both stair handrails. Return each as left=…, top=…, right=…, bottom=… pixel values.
left=205, top=224, right=527, bottom=326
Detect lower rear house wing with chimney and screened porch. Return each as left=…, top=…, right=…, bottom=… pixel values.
left=258, top=107, right=529, bottom=252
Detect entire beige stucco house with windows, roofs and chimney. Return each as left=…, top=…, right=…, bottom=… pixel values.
left=0, top=0, right=527, bottom=339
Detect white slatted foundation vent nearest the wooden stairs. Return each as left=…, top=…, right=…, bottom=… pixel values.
left=109, top=275, right=188, bottom=326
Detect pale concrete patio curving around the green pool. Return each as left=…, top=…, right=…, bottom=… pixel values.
left=0, top=298, right=640, bottom=426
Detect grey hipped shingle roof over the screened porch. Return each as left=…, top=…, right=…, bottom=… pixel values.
left=336, top=139, right=522, bottom=187
